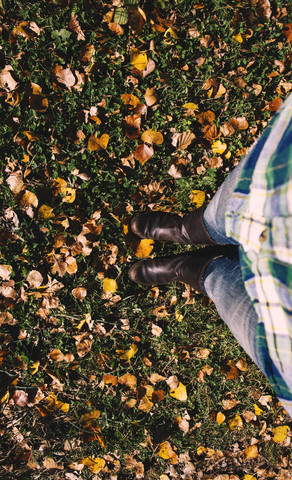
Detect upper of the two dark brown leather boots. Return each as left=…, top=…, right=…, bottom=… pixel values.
left=131, top=206, right=218, bottom=245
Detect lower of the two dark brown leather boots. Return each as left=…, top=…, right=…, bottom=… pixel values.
left=128, top=245, right=238, bottom=294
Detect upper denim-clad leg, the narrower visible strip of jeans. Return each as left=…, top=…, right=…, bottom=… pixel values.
left=203, top=156, right=247, bottom=245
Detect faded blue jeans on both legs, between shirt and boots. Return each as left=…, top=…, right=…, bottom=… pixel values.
left=203, top=158, right=263, bottom=370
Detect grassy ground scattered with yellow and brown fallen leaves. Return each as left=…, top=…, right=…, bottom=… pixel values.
left=0, top=0, right=292, bottom=480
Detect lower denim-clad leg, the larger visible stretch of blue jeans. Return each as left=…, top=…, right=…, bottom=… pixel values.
left=203, top=258, right=263, bottom=371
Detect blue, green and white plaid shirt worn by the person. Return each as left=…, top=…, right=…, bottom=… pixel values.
left=225, top=95, right=292, bottom=416
